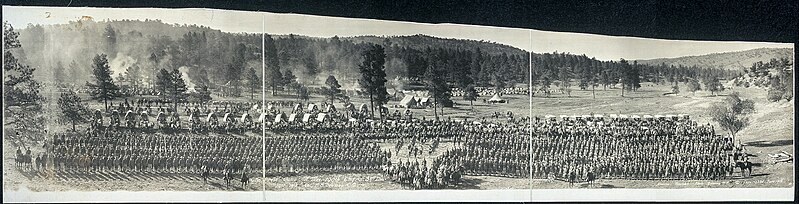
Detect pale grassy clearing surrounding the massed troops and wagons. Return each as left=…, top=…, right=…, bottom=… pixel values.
left=3, top=83, right=794, bottom=191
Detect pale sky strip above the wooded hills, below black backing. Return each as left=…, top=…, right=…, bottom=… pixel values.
left=3, top=6, right=793, bottom=60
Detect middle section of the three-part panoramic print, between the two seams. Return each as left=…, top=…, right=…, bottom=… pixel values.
left=264, top=13, right=530, bottom=191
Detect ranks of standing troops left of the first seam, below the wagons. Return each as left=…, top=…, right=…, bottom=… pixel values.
left=45, top=128, right=261, bottom=189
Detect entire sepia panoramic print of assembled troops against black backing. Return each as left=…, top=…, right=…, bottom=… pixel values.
left=2, top=2, right=796, bottom=202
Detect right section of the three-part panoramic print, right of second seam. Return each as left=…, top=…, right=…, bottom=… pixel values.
left=531, top=31, right=795, bottom=189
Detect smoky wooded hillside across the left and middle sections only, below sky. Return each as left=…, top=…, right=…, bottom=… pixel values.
left=13, top=19, right=528, bottom=91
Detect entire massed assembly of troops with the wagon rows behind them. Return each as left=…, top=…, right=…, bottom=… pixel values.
left=18, top=92, right=751, bottom=189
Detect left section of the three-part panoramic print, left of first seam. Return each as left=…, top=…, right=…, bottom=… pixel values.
left=3, top=6, right=266, bottom=191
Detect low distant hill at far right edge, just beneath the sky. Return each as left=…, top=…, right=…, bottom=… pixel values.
left=638, top=48, right=793, bottom=71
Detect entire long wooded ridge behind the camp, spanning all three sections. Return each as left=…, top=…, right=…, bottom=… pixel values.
left=14, top=20, right=740, bottom=95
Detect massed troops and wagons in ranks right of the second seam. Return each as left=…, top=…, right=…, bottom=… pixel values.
left=531, top=115, right=735, bottom=182
